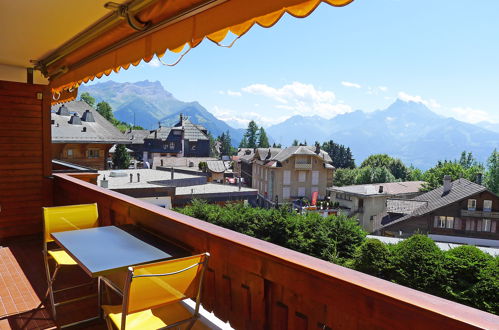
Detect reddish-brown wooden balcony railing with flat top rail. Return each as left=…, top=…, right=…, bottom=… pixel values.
left=53, top=174, right=499, bottom=329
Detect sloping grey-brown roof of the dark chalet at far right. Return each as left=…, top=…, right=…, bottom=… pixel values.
left=385, top=179, right=487, bottom=226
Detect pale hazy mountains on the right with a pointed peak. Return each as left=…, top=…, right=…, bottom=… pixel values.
left=267, top=100, right=499, bottom=169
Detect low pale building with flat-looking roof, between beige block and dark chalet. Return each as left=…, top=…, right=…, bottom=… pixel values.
left=328, top=181, right=423, bottom=233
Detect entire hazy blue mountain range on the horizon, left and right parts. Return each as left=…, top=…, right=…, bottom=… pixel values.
left=79, top=81, right=499, bottom=169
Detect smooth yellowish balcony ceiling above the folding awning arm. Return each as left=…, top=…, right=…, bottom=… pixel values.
left=0, top=0, right=126, bottom=67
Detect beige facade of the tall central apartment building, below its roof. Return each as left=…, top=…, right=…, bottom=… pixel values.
left=252, top=156, right=333, bottom=202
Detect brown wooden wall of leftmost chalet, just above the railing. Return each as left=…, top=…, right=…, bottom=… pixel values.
left=52, top=143, right=113, bottom=170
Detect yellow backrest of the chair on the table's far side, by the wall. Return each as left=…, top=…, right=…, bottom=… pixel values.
left=43, top=203, right=99, bottom=243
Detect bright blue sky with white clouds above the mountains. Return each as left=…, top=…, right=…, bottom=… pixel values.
left=86, top=0, right=499, bottom=127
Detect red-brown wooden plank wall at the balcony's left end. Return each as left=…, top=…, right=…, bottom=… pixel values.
left=0, top=81, right=52, bottom=239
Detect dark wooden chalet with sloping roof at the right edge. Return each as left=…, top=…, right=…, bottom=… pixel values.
left=380, top=175, right=499, bottom=240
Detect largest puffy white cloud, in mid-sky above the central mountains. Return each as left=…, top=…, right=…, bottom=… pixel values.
left=242, top=82, right=352, bottom=118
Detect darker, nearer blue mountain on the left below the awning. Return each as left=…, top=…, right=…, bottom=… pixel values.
left=78, top=80, right=244, bottom=145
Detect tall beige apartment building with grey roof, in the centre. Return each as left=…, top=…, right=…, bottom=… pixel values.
left=252, top=146, right=334, bottom=203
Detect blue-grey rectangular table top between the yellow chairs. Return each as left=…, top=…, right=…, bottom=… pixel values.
left=51, top=226, right=183, bottom=277
